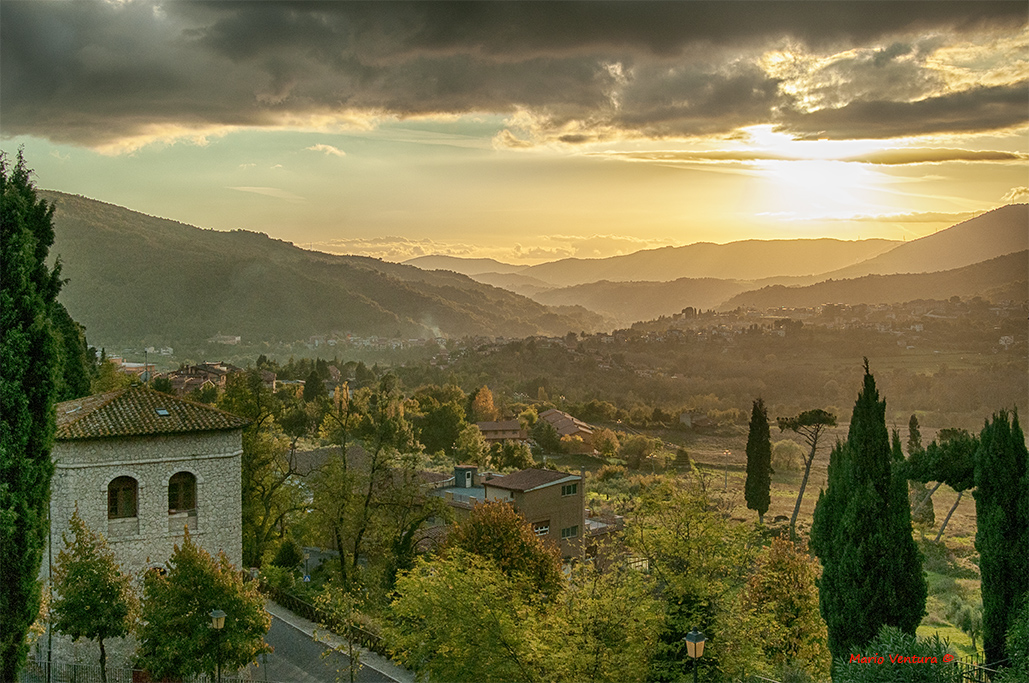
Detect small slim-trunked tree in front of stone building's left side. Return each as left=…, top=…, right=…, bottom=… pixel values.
left=50, top=507, right=137, bottom=683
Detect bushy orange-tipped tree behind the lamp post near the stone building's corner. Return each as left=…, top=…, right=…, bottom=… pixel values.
left=137, top=531, right=272, bottom=680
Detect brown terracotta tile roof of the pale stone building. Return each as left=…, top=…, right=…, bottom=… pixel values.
left=57, top=387, right=250, bottom=440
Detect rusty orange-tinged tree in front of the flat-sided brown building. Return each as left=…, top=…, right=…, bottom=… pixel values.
left=447, top=502, right=564, bottom=596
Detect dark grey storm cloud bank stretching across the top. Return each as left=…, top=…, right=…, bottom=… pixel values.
left=0, top=0, right=1026, bottom=145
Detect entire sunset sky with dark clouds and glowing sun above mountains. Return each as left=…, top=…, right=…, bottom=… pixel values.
left=0, top=0, right=1029, bottom=263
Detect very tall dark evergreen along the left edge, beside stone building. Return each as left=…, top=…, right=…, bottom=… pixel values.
left=0, top=152, right=61, bottom=681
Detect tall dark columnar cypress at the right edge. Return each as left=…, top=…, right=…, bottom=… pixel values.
left=972, top=410, right=1029, bottom=662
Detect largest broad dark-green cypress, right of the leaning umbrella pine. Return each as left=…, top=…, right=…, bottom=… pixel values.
left=811, top=359, right=927, bottom=657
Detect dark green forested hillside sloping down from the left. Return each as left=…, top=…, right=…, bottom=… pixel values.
left=40, top=190, right=602, bottom=345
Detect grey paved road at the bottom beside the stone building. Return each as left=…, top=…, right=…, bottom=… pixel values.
left=253, top=615, right=393, bottom=683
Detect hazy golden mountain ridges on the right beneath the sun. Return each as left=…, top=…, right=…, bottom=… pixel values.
left=407, top=204, right=1029, bottom=325
